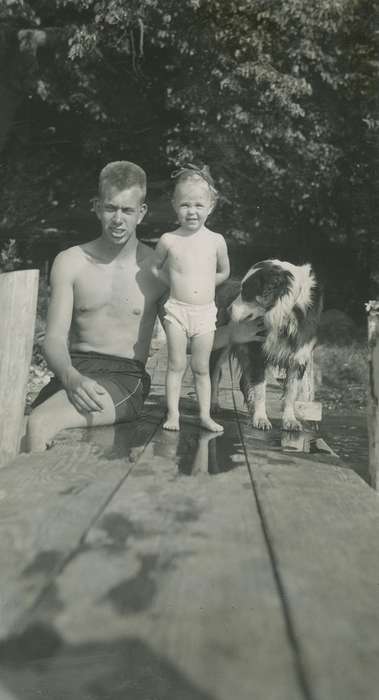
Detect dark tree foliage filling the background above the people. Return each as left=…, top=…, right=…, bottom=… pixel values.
left=0, top=0, right=379, bottom=308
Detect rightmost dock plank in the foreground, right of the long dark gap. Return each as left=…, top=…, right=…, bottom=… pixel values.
left=241, top=416, right=379, bottom=700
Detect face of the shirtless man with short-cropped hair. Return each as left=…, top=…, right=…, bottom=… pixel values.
left=96, top=186, right=147, bottom=246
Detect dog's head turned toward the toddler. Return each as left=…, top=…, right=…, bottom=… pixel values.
left=230, top=260, right=293, bottom=321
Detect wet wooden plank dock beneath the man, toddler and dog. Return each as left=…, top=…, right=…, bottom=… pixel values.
left=0, top=353, right=379, bottom=700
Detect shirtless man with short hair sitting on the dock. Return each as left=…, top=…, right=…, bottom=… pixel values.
left=27, top=161, right=261, bottom=451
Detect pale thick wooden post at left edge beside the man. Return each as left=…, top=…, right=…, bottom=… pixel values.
left=0, top=270, right=39, bottom=467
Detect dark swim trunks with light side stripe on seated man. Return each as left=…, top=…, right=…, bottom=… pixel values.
left=32, top=352, right=150, bottom=423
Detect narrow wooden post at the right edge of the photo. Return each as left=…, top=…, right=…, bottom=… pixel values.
left=366, top=301, right=379, bottom=489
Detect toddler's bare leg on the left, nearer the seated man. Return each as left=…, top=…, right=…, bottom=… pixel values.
left=163, top=321, right=187, bottom=430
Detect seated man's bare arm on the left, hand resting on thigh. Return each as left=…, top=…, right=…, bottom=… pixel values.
left=43, top=251, right=104, bottom=411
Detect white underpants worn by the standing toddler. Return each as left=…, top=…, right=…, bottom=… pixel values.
left=163, top=298, right=217, bottom=338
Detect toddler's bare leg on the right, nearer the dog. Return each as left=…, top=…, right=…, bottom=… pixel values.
left=191, top=333, right=224, bottom=433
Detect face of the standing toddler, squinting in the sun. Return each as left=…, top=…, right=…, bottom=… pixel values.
left=172, top=181, right=214, bottom=233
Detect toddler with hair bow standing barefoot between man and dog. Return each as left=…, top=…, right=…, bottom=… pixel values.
left=153, top=165, right=230, bottom=432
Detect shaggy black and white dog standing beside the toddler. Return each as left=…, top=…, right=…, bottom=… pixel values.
left=211, top=260, right=322, bottom=431
